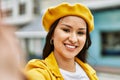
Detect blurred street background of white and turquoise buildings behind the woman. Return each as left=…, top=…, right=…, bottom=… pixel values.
left=0, top=0, right=120, bottom=80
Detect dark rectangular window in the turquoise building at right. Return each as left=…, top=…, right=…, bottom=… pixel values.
left=101, top=31, right=120, bottom=56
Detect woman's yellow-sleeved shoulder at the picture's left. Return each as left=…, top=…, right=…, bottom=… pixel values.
left=25, top=59, right=50, bottom=80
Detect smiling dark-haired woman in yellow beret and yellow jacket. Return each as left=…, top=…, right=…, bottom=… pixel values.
left=26, top=3, right=98, bottom=80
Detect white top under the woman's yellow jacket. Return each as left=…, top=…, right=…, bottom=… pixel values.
left=60, top=63, right=89, bottom=80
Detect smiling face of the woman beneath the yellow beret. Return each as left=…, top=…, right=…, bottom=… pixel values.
left=52, top=16, right=87, bottom=59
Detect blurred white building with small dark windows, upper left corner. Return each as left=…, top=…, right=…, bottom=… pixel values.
left=0, top=0, right=40, bottom=26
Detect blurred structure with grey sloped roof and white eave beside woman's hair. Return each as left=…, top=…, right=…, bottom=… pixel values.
left=16, top=16, right=47, bottom=59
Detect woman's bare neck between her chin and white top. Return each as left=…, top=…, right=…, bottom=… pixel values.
left=54, top=53, right=76, bottom=72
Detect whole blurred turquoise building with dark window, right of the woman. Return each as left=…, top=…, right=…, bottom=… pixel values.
left=88, top=0, right=120, bottom=74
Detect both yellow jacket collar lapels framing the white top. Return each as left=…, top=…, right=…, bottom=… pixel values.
left=45, top=52, right=98, bottom=80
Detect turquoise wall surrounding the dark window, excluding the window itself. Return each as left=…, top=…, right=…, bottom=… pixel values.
left=88, top=8, right=120, bottom=67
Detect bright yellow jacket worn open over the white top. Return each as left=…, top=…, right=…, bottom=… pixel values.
left=25, top=53, right=98, bottom=80
